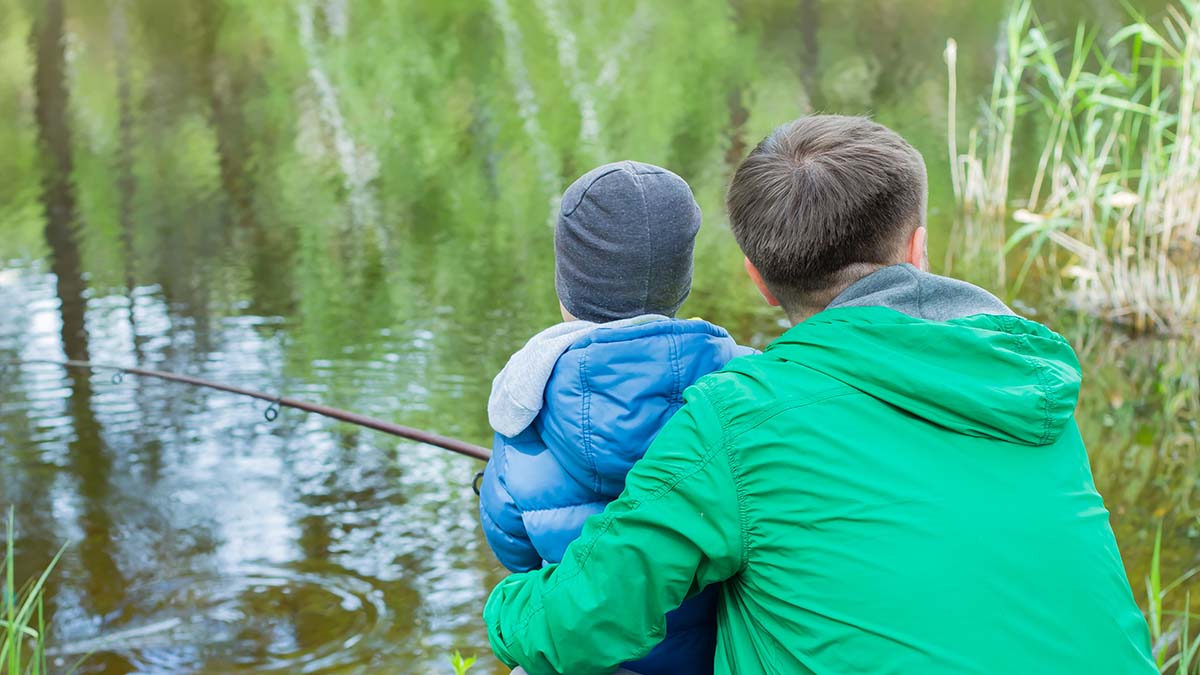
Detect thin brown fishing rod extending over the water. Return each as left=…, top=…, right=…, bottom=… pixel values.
left=14, top=359, right=492, bottom=461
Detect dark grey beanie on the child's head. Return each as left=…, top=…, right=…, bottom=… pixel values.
left=554, top=161, right=700, bottom=322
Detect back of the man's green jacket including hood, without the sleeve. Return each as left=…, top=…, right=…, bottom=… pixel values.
left=700, top=300, right=1154, bottom=675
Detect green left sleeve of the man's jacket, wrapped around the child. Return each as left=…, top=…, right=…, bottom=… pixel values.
left=484, top=387, right=745, bottom=675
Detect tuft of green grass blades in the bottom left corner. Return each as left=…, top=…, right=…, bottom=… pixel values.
left=0, top=508, right=65, bottom=675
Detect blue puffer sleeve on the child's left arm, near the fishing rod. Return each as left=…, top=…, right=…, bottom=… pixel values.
left=479, top=434, right=541, bottom=572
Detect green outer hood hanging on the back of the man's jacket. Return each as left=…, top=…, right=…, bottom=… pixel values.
left=766, top=307, right=1080, bottom=446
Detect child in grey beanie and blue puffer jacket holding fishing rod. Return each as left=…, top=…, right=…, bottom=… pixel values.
left=480, top=161, right=743, bottom=675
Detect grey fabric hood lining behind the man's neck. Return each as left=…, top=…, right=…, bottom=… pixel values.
left=827, top=263, right=1014, bottom=321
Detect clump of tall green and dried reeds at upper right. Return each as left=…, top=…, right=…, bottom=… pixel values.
left=946, top=0, right=1200, bottom=334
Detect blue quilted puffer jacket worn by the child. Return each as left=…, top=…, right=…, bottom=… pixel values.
left=480, top=318, right=749, bottom=675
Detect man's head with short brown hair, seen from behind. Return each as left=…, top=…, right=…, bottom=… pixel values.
left=726, top=115, right=928, bottom=310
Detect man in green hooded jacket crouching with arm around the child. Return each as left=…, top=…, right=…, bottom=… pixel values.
left=484, top=117, right=1156, bottom=675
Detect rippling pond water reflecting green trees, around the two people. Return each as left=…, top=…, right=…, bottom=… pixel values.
left=0, top=0, right=1200, bottom=674
